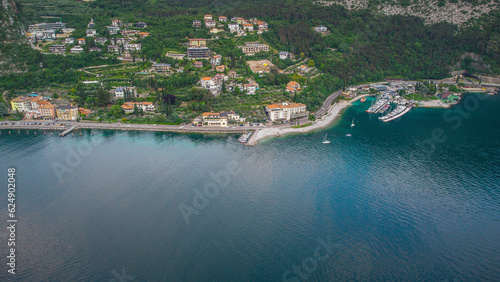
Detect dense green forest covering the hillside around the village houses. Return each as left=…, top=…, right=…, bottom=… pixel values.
left=0, top=0, right=500, bottom=114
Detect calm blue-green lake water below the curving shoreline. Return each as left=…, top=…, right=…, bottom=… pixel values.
left=0, top=95, right=500, bottom=281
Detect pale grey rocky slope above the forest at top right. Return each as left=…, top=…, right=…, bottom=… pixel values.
left=315, top=0, right=500, bottom=26
